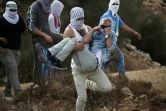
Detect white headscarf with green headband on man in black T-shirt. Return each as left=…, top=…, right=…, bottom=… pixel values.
left=3, top=1, right=19, bottom=24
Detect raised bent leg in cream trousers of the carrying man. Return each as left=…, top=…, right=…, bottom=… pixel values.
left=86, top=68, right=112, bottom=92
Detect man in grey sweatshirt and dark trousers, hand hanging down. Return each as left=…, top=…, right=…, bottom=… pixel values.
left=27, top=0, right=63, bottom=83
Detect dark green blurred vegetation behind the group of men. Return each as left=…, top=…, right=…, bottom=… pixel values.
left=0, top=0, right=166, bottom=82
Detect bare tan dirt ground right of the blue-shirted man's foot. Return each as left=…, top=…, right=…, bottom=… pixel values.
left=110, top=69, right=166, bottom=97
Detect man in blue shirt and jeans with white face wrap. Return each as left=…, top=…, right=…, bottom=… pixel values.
left=100, top=0, right=142, bottom=81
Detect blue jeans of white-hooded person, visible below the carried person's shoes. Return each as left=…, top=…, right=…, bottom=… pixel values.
left=42, top=63, right=56, bottom=80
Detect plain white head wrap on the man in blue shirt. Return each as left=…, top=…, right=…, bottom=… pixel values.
left=108, top=0, right=120, bottom=16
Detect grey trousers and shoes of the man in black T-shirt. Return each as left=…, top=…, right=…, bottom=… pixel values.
left=0, top=49, right=22, bottom=96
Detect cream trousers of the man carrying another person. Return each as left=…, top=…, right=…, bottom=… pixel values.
left=72, top=67, right=112, bottom=111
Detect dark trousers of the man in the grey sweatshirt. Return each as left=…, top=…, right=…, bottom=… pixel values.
left=32, top=31, right=63, bottom=84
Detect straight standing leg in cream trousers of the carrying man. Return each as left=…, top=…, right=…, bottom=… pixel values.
left=72, top=69, right=87, bottom=111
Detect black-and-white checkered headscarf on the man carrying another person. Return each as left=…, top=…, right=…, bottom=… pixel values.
left=70, top=7, right=84, bottom=30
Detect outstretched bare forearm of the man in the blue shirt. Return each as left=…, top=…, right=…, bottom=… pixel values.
left=122, top=24, right=142, bottom=39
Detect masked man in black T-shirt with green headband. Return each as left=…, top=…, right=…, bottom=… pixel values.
left=0, top=1, right=29, bottom=97
